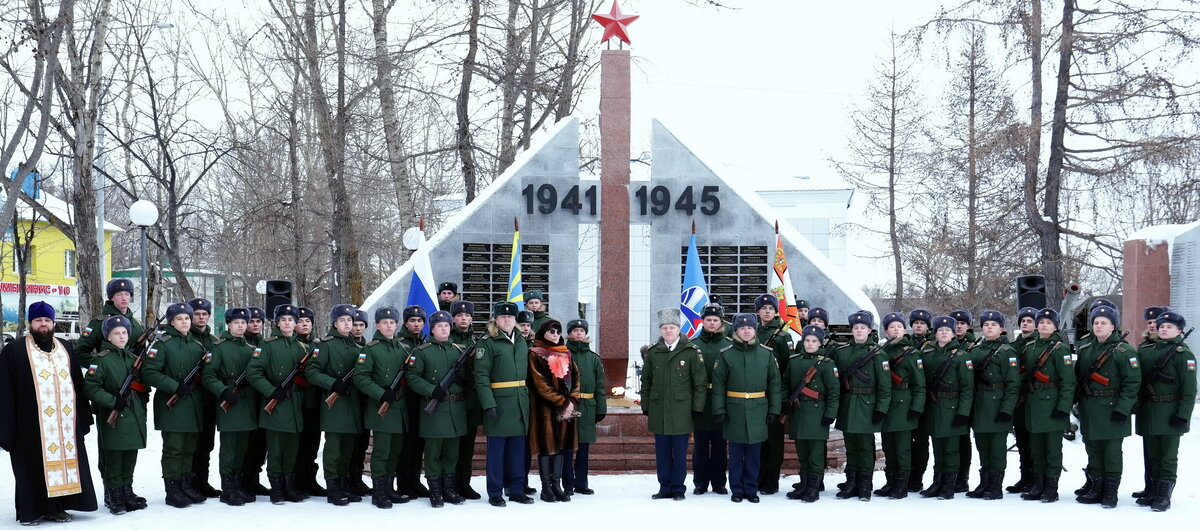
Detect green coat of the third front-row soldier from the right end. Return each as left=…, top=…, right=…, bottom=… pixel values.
left=1021, top=331, right=1075, bottom=433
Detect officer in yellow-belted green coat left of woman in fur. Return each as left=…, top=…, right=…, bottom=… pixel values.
left=474, top=302, right=533, bottom=507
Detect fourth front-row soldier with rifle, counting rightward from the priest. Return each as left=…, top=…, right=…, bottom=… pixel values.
left=246, top=303, right=307, bottom=505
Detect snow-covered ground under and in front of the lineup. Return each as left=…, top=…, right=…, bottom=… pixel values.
left=0, top=408, right=1200, bottom=530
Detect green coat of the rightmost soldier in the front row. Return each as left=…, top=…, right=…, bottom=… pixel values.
left=1138, top=337, right=1196, bottom=436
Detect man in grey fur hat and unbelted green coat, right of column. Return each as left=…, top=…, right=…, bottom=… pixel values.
left=641, top=307, right=715, bottom=500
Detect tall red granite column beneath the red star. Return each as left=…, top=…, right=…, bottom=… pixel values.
left=596, top=49, right=630, bottom=392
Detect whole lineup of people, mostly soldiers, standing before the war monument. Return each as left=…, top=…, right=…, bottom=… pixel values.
left=0, top=275, right=1196, bottom=524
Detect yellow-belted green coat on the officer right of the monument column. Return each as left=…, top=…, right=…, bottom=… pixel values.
left=713, top=338, right=784, bottom=444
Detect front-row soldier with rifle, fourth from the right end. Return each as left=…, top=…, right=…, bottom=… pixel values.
left=959, top=309, right=1021, bottom=500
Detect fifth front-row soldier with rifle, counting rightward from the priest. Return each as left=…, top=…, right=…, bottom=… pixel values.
left=305, top=303, right=362, bottom=506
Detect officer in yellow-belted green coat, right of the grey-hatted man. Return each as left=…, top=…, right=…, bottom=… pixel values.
left=712, top=313, right=782, bottom=502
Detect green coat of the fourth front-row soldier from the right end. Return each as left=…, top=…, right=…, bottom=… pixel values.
left=967, top=335, right=1021, bottom=433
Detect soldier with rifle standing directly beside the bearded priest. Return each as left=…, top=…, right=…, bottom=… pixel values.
left=84, top=315, right=149, bottom=516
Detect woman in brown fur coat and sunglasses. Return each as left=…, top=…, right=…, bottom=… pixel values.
left=529, top=319, right=580, bottom=502
